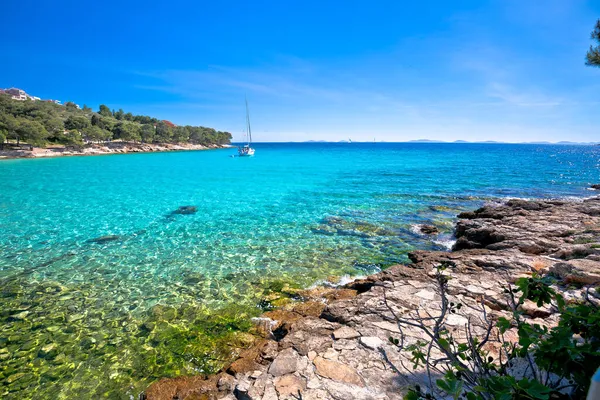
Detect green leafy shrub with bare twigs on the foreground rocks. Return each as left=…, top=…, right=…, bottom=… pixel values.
left=389, top=267, right=600, bottom=400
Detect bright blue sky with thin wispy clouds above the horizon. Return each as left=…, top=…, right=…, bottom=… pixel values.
left=0, top=0, right=600, bottom=142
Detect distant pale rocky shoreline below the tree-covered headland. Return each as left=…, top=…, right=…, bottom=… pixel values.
left=0, top=142, right=231, bottom=159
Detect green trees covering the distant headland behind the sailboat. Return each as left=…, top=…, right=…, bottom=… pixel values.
left=0, top=94, right=231, bottom=147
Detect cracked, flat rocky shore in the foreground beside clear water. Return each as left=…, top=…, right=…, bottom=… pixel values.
left=142, top=198, right=600, bottom=400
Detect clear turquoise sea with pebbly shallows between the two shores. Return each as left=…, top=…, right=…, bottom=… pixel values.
left=0, top=143, right=600, bottom=399
